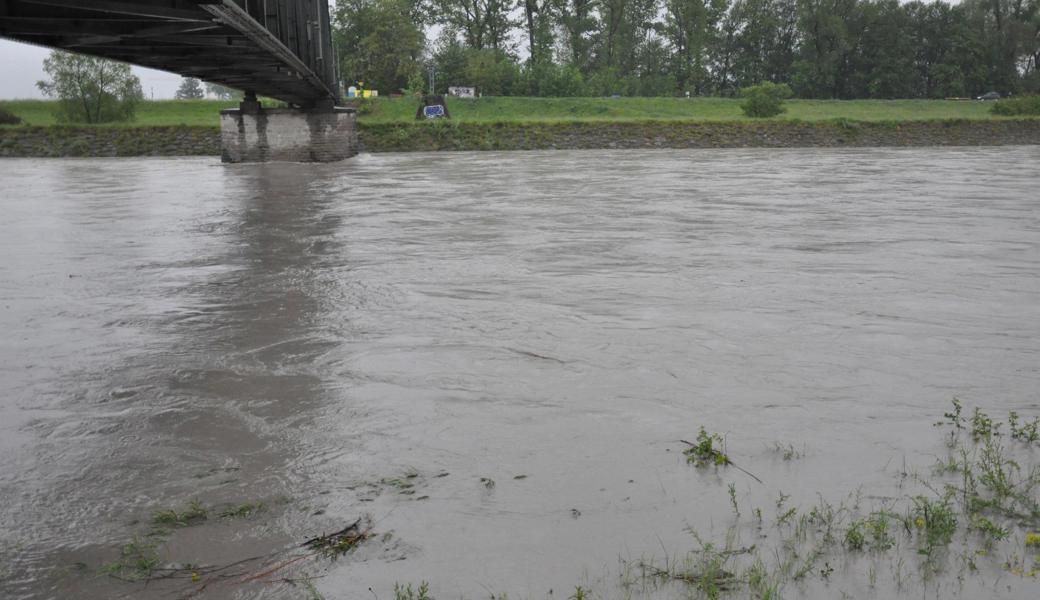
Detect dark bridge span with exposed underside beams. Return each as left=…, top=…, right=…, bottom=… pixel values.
left=0, top=0, right=339, bottom=107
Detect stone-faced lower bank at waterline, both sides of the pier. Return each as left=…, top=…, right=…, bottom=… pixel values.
left=0, top=119, right=1040, bottom=157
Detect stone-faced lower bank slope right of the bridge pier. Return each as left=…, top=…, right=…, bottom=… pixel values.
left=359, top=119, right=1040, bottom=152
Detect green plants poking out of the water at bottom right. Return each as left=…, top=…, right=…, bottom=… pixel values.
left=622, top=398, right=1040, bottom=599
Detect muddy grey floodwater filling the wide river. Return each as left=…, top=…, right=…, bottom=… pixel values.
left=0, top=147, right=1040, bottom=600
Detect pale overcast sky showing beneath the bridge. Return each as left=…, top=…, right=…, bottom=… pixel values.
left=0, top=40, right=181, bottom=100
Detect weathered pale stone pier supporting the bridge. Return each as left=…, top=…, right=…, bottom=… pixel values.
left=220, top=99, right=358, bottom=162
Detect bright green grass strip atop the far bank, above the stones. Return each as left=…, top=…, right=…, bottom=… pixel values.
left=0, top=98, right=1000, bottom=127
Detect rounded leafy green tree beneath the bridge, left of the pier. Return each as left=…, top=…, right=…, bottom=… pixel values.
left=36, top=50, right=145, bottom=123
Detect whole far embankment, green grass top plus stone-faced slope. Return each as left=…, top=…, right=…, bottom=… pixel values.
left=0, top=98, right=1040, bottom=156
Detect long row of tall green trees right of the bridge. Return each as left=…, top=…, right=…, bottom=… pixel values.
left=333, top=0, right=1040, bottom=99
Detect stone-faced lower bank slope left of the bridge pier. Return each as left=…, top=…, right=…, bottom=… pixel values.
left=0, top=127, right=220, bottom=157
